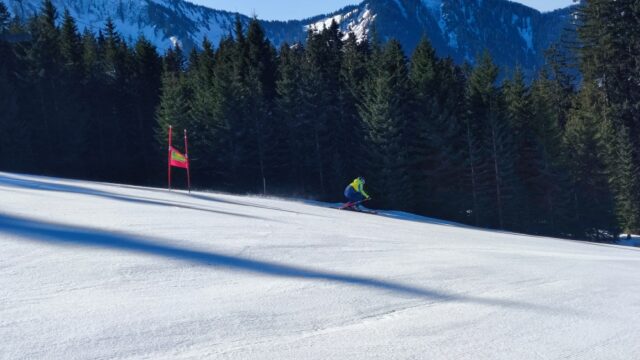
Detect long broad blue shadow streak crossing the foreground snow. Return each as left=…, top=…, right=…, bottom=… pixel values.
left=0, top=214, right=580, bottom=313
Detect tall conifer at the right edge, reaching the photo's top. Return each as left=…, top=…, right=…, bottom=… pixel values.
left=576, top=0, right=640, bottom=239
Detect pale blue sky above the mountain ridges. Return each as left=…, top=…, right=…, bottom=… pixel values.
left=188, top=0, right=572, bottom=20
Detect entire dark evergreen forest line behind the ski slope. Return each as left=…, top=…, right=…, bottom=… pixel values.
left=0, top=0, right=640, bottom=241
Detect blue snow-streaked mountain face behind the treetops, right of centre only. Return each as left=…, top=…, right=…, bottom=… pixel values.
left=312, top=0, right=572, bottom=71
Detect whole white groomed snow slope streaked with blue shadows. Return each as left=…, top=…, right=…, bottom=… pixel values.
left=0, top=173, right=640, bottom=360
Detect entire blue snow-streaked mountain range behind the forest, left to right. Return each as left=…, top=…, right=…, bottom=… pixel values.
left=8, top=0, right=571, bottom=70
